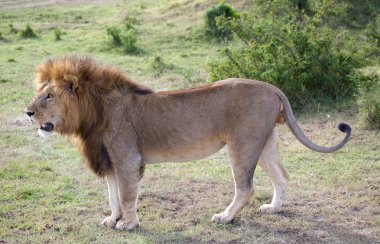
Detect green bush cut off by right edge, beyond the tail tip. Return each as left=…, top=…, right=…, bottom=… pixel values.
left=357, top=75, right=380, bottom=130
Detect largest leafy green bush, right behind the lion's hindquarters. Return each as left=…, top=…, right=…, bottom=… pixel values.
left=210, top=0, right=364, bottom=108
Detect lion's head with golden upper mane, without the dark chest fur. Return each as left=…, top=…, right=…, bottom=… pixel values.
left=26, top=55, right=152, bottom=136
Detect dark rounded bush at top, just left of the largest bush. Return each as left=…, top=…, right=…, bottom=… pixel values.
left=205, top=3, right=239, bottom=40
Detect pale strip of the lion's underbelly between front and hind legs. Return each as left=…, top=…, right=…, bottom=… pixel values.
left=142, top=141, right=225, bottom=164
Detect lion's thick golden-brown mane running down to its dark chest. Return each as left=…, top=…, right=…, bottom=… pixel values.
left=36, top=55, right=153, bottom=176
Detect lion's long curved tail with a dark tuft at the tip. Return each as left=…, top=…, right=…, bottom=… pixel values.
left=275, top=88, right=351, bottom=153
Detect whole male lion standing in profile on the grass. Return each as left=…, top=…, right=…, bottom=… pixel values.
left=26, top=56, right=351, bottom=230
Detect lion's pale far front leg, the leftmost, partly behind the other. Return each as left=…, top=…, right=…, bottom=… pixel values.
left=102, top=172, right=121, bottom=228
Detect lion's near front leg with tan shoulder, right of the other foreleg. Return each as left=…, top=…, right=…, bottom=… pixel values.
left=105, top=121, right=143, bottom=230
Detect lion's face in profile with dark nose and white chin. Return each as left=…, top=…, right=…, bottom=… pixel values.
left=26, top=83, right=65, bottom=137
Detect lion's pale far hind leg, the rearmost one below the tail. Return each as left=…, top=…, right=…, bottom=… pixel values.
left=259, top=128, right=289, bottom=213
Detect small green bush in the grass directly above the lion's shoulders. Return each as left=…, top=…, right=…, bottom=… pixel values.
left=106, top=22, right=139, bottom=53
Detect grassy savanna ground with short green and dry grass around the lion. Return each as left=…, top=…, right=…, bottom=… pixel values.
left=0, top=0, right=380, bottom=243
